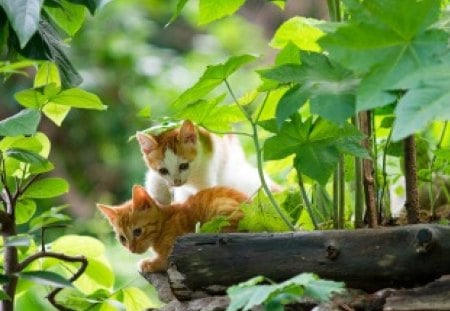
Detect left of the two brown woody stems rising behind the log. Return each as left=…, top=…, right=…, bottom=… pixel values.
left=359, top=111, right=378, bottom=228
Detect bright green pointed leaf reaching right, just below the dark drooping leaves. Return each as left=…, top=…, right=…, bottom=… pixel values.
left=51, top=88, right=106, bottom=110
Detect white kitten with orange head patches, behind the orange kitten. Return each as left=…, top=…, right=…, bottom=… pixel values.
left=136, top=120, right=279, bottom=204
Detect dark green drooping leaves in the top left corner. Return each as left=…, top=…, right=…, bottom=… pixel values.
left=0, top=0, right=99, bottom=87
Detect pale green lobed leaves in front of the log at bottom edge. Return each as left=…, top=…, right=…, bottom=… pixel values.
left=227, top=273, right=344, bottom=311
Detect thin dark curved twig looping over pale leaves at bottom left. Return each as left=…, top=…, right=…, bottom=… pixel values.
left=17, top=252, right=88, bottom=311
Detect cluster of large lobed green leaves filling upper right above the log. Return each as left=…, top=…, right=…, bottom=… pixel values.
left=167, top=0, right=450, bottom=229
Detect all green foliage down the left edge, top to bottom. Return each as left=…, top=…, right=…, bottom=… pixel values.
left=0, top=0, right=160, bottom=310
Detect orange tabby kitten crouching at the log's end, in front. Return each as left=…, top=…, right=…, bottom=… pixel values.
left=97, top=185, right=247, bottom=272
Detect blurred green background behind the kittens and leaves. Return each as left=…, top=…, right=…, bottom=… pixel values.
left=0, top=0, right=327, bottom=308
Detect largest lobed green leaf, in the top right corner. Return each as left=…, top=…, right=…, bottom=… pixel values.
left=319, top=0, right=448, bottom=111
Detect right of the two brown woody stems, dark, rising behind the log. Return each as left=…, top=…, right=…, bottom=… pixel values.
left=403, top=135, right=419, bottom=224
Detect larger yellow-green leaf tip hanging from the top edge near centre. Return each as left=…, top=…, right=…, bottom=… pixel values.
left=199, top=0, right=245, bottom=25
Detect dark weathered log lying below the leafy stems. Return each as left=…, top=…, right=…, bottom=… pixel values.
left=168, top=225, right=450, bottom=300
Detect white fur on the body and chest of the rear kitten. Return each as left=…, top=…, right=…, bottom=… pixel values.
left=146, top=135, right=276, bottom=204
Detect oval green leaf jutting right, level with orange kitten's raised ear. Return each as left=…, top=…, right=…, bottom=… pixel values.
left=22, top=178, right=69, bottom=199
